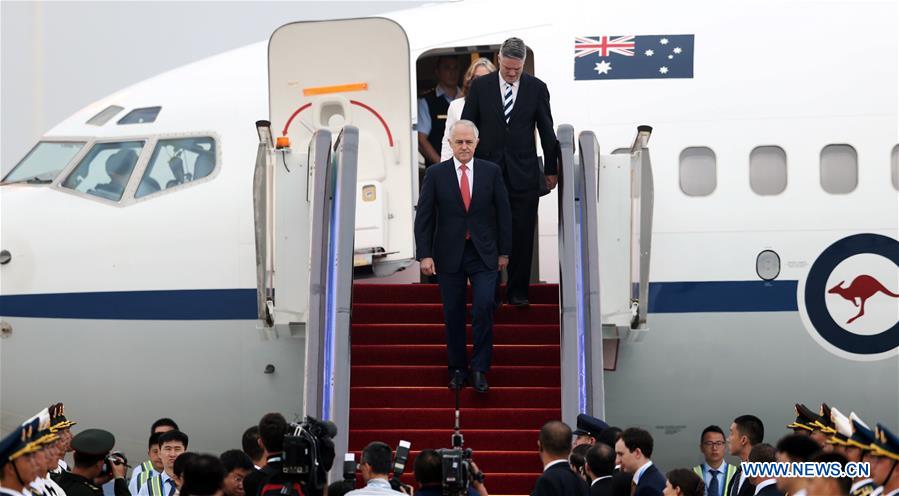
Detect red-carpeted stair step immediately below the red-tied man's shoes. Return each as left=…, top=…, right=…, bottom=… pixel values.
left=350, top=381, right=562, bottom=408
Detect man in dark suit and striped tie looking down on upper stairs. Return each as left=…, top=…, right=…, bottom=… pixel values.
left=462, top=38, right=559, bottom=306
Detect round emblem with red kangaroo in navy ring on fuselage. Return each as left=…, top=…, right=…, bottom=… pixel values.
left=797, top=233, right=899, bottom=360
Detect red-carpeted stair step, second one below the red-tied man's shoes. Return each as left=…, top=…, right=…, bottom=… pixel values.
left=350, top=408, right=562, bottom=430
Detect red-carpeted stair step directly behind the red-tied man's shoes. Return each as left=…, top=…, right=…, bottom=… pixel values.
left=350, top=365, right=561, bottom=387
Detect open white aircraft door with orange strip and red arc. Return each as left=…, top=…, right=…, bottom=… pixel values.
left=269, top=18, right=417, bottom=276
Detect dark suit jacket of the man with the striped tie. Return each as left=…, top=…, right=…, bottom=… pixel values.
left=462, top=72, right=559, bottom=194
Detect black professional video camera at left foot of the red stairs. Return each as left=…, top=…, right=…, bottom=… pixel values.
left=282, top=416, right=337, bottom=496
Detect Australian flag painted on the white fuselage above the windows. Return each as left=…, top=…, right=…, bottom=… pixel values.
left=574, top=34, right=693, bottom=81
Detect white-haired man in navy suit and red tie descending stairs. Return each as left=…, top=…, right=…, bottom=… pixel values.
left=415, top=119, right=512, bottom=393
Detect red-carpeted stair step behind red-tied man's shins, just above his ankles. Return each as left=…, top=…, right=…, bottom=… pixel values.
left=352, top=344, right=560, bottom=366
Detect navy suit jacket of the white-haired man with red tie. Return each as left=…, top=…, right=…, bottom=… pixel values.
left=415, top=158, right=512, bottom=275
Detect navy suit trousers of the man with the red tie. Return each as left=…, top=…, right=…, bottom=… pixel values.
left=437, top=240, right=499, bottom=373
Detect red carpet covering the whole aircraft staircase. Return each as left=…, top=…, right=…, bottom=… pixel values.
left=349, top=284, right=561, bottom=495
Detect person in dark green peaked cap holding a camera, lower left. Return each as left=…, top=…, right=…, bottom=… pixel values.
left=55, top=429, right=131, bottom=496
